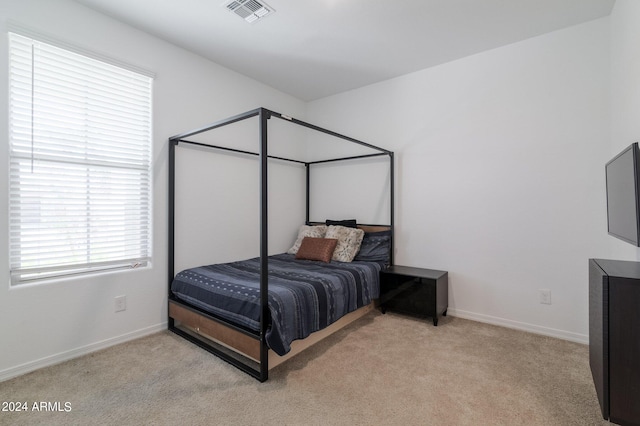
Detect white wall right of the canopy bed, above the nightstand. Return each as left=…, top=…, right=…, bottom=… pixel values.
left=307, top=18, right=612, bottom=342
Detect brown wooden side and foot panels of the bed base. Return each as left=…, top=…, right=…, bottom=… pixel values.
left=169, top=301, right=374, bottom=370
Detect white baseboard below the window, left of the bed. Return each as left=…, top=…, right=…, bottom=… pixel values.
left=0, top=322, right=167, bottom=382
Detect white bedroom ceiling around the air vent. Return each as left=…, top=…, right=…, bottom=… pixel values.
left=75, top=0, right=615, bottom=101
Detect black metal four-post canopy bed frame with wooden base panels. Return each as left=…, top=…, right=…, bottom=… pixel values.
left=168, top=108, right=394, bottom=382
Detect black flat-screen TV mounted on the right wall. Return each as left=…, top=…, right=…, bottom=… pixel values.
left=605, top=142, right=640, bottom=247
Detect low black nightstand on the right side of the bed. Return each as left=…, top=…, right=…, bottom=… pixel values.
left=380, top=265, right=449, bottom=326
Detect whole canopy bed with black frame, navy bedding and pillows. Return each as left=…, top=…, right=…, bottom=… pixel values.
left=169, top=108, right=393, bottom=381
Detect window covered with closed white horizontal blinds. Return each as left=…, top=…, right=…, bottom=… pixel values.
left=9, top=33, right=152, bottom=284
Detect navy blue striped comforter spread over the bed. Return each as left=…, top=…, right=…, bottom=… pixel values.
left=171, top=254, right=382, bottom=355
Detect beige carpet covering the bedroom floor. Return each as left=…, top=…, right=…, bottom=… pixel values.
left=0, top=312, right=606, bottom=426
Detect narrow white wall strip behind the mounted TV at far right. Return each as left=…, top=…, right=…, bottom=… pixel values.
left=609, top=0, right=640, bottom=260
